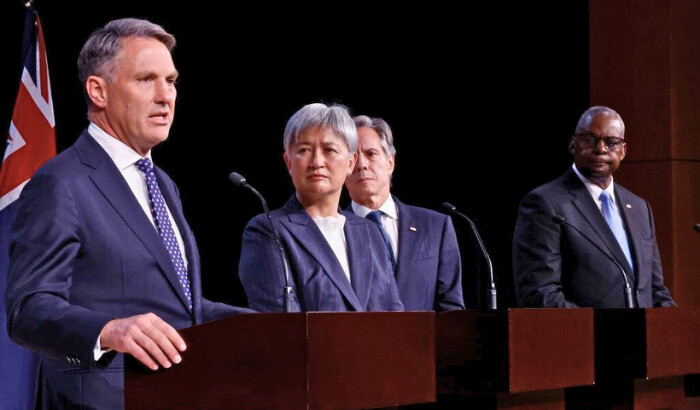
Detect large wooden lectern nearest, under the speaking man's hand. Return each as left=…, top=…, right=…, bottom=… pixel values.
left=124, top=312, right=435, bottom=410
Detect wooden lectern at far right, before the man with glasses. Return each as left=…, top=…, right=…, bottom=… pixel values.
left=567, top=307, right=700, bottom=409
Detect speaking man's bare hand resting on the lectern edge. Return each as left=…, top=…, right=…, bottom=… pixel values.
left=100, top=313, right=187, bottom=370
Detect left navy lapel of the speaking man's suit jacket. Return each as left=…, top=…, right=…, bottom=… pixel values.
left=75, top=135, right=189, bottom=310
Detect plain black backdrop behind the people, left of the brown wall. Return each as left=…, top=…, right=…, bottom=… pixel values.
left=0, top=0, right=589, bottom=305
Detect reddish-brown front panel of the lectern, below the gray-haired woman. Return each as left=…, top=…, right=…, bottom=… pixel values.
left=308, top=312, right=435, bottom=409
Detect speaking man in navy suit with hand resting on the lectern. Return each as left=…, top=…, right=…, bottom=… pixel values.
left=6, top=19, right=252, bottom=409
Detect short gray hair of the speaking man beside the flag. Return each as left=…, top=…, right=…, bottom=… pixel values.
left=78, top=18, right=175, bottom=88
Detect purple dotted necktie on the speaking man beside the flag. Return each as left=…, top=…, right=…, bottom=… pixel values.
left=136, top=158, right=192, bottom=310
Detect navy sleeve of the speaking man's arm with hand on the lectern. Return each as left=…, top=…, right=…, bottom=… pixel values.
left=5, top=174, right=114, bottom=367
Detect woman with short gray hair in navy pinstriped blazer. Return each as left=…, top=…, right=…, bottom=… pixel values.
left=238, top=103, right=403, bottom=312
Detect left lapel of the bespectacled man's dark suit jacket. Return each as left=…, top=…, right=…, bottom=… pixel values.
left=568, top=170, right=632, bottom=278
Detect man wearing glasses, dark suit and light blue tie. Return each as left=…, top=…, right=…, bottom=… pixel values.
left=513, top=107, right=675, bottom=308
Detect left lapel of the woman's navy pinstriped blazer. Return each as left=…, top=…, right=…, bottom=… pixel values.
left=280, top=196, right=364, bottom=311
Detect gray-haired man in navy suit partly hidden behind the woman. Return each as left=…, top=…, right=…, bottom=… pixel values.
left=345, top=115, right=464, bottom=311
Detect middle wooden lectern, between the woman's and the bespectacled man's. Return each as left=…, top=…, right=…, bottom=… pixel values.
left=436, top=309, right=594, bottom=409
